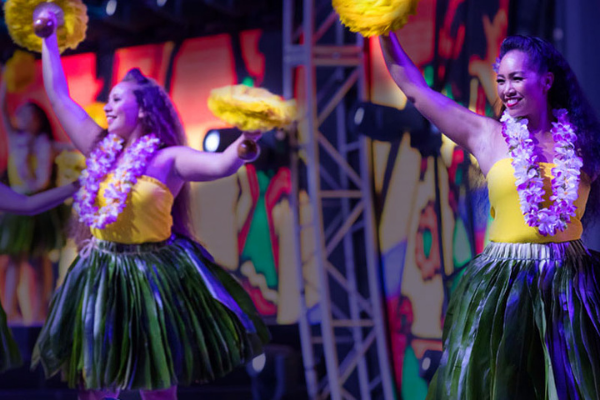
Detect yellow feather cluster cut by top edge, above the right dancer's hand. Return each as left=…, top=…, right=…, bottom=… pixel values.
left=332, top=0, right=419, bottom=37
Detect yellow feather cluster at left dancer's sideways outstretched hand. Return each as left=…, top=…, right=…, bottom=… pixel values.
left=208, top=85, right=297, bottom=132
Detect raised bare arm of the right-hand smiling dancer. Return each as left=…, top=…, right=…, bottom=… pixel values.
left=380, top=32, right=500, bottom=158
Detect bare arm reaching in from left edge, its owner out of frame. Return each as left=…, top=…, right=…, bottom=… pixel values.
left=0, top=182, right=79, bottom=215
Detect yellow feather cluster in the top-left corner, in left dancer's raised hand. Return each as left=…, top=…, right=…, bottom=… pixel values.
left=4, top=0, right=88, bottom=53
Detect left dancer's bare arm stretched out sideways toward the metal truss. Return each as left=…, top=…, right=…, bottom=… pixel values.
left=170, top=135, right=254, bottom=182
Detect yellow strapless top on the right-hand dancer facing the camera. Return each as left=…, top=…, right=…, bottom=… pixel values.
left=487, top=158, right=590, bottom=243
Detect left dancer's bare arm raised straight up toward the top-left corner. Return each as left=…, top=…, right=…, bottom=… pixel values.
left=42, top=17, right=102, bottom=155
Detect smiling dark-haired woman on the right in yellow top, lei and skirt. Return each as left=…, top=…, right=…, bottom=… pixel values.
left=380, top=33, right=600, bottom=400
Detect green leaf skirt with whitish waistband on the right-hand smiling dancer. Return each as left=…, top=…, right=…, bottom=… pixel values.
left=427, top=241, right=600, bottom=400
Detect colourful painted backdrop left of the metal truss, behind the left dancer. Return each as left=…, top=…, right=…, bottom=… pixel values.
left=0, top=30, right=300, bottom=323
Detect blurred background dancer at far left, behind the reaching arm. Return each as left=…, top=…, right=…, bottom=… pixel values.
left=0, top=79, right=69, bottom=325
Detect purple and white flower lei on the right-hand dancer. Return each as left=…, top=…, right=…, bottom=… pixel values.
left=500, top=109, right=583, bottom=236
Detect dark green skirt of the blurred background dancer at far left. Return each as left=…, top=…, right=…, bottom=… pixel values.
left=0, top=205, right=71, bottom=257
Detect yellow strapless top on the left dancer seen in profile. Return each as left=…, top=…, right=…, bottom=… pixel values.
left=92, top=175, right=174, bottom=244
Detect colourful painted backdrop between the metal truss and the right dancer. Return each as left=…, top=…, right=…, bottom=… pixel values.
left=370, top=0, right=508, bottom=400
